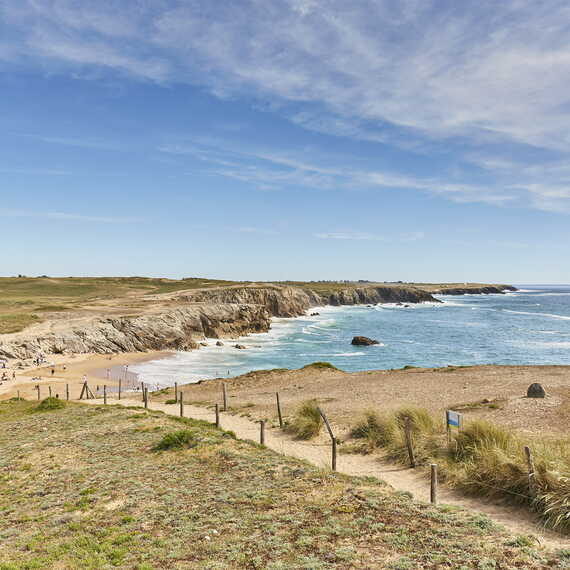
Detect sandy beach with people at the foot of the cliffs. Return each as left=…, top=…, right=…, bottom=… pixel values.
left=0, top=351, right=172, bottom=400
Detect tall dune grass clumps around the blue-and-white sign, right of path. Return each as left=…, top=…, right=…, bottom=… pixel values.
left=351, top=408, right=570, bottom=533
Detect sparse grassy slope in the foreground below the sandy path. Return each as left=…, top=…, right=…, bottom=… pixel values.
left=0, top=401, right=570, bottom=570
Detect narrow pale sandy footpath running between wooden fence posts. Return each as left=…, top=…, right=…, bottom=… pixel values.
left=83, top=399, right=570, bottom=549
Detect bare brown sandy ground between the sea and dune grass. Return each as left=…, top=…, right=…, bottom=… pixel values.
left=165, top=366, right=570, bottom=437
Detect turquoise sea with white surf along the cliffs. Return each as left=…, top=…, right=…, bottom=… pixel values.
left=131, top=285, right=570, bottom=385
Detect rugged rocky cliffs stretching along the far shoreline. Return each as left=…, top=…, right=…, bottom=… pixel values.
left=0, top=284, right=514, bottom=360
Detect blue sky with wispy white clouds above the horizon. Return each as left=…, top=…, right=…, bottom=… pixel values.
left=0, top=0, right=570, bottom=283
